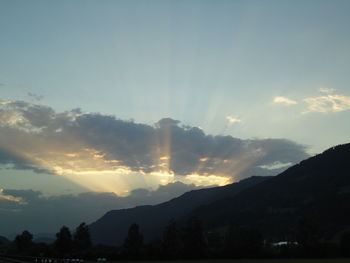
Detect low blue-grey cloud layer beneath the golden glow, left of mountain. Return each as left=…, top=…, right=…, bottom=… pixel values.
left=0, top=182, right=197, bottom=234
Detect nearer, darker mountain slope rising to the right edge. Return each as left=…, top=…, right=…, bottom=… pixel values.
left=191, top=144, right=350, bottom=238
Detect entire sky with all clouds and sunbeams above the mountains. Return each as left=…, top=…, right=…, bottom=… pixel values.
left=0, top=0, right=350, bottom=234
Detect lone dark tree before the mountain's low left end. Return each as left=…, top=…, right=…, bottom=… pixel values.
left=123, top=223, right=143, bottom=258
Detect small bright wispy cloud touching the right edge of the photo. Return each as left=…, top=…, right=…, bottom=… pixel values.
left=303, top=94, right=350, bottom=113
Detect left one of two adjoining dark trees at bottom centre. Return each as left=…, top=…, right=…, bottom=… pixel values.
left=162, top=220, right=182, bottom=259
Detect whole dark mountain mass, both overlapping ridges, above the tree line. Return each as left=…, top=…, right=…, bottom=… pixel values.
left=90, top=144, right=350, bottom=245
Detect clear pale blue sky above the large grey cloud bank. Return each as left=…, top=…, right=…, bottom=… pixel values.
left=0, top=0, right=350, bottom=195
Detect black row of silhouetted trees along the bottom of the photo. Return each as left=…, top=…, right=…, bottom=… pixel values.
left=0, top=217, right=350, bottom=260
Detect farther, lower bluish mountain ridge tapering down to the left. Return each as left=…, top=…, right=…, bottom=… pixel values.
left=89, top=176, right=268, bottom=245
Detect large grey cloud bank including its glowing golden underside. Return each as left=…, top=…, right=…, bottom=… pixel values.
left=0, top=101, right=308, bottom=194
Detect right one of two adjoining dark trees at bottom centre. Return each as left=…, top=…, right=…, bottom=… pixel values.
left=182, top=217, right=207, bottom=258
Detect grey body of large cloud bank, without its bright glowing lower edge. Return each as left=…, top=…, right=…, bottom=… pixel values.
left=0, top=101, right=308, bottom=179
